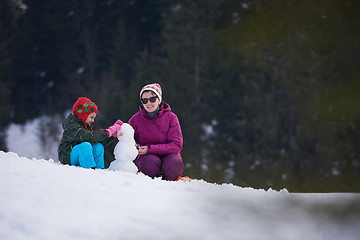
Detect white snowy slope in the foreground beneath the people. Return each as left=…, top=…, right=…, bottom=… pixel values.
left=0, top=152, right=360, bottom=240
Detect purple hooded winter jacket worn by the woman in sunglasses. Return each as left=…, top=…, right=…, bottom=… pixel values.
left=128, top=102, right=183, bottom=155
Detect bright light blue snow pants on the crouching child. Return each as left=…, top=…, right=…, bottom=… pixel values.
left=70, top=142, right=104, bottom=168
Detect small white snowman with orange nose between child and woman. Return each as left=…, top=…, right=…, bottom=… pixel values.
left=109, top=123, right=138, bottom=173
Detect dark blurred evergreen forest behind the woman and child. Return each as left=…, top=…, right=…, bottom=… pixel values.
left=0, top=0, right=360, bottom=192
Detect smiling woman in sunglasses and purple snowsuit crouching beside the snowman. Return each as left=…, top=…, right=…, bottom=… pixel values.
left=128, top=83, right=184, bottom=181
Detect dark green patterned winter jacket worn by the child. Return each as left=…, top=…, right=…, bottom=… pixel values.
left=58, top=114, right=115, bottom=165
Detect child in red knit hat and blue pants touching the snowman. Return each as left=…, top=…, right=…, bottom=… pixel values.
left=58, top=97, right=123, bottom=168
